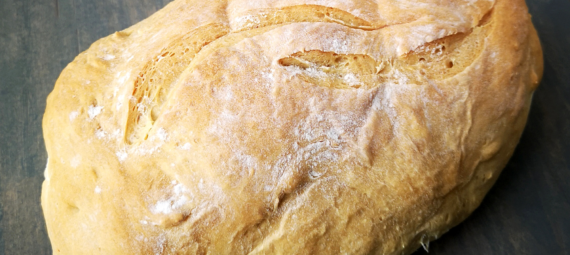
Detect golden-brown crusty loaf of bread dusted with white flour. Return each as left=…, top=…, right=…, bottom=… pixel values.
left=41, top=0, right=542, bottom=254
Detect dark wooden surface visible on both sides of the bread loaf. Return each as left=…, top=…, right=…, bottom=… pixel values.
left=0, top=0, right=570, bottom=255
